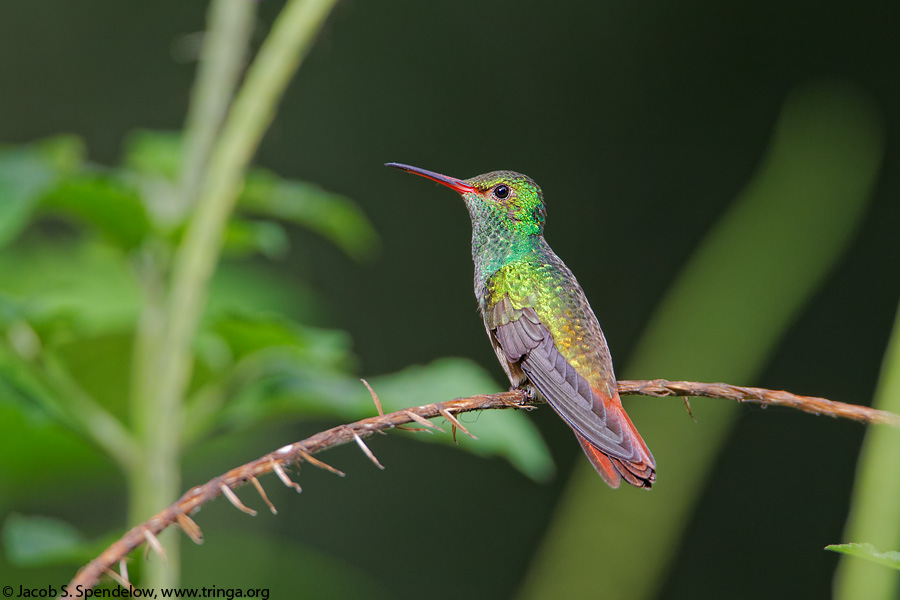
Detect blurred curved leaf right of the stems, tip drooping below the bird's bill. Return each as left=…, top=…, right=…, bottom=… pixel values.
left=238, top=169, right=378, bottom=260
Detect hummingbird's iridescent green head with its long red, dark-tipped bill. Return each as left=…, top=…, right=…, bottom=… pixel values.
left=387, top=163, right=547, bottom=235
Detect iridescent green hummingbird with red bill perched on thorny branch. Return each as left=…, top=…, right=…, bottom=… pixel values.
left=386, top=163, right=656, bottom=488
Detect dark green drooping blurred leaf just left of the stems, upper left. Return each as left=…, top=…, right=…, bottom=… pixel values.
left=41, top=175, right=150, bottom=250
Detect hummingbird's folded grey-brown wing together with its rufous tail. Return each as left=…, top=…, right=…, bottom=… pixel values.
left=492, top=296, right=656, bottom=487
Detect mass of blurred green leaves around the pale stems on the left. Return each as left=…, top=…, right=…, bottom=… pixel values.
left=0, top=131, right=552, bottom=566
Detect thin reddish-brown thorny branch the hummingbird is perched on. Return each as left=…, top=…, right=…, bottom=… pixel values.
left=68, top=379, right=900, bottom=589
